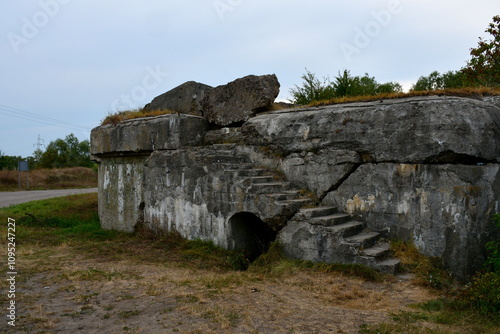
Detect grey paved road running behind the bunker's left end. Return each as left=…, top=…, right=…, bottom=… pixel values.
left=0, top=188, right=97, bottom=208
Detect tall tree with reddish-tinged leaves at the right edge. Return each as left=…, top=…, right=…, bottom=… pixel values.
left=463, top=15, right=500, bottom=87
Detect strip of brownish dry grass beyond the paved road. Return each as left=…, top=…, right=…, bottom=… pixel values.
left=0, top=167, right=97, bottom=191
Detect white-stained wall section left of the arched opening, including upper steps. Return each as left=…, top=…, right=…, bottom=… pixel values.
left=144, top=147, right=306, bottom=249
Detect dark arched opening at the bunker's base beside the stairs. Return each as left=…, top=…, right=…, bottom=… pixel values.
left=229, top=212, right=276, bottom=262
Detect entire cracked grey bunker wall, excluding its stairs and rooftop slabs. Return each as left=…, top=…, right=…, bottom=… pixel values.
left=91, top=96, right=500, bottom=277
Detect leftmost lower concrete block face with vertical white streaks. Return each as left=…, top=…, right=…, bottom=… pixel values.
left=98, top=156, right=146, bottom=232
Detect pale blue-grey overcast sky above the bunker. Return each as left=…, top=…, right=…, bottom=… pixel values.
left=0, top=0, right=500, bottom=157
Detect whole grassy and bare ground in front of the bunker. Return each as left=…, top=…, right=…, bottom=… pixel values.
left=0, top=194, right=499, bottom=334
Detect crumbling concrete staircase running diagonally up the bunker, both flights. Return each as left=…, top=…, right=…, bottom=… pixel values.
left=206, top=145, right=400, bottom=274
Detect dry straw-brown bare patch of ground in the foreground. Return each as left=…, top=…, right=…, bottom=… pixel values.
left=0, top=245, right=432, bottom=334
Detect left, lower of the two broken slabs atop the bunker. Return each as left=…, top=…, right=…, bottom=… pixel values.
left=144, top=81, right=213, bottom=116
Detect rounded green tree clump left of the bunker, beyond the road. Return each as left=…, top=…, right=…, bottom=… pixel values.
left=38, top=134, right=92, bottom=168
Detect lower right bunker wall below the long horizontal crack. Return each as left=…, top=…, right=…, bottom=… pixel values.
left=323, top=163, right=500, bottom=278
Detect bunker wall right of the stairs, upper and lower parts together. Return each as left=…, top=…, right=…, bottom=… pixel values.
left=235, top=97, right=500, bottom=278
